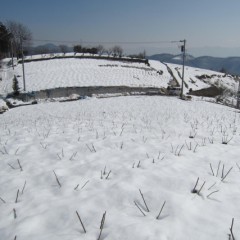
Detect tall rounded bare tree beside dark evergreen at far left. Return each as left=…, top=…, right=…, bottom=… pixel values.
left=6, top=21, right=32, bottom=58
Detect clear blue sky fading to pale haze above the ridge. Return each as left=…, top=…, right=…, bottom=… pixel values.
left=0, top=0, right=240, bottom=56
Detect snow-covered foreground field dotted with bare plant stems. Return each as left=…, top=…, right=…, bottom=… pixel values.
left=0, top=96, right=240, bottom=240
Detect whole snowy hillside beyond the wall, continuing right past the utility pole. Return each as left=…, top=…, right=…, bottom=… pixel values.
left=0, top=55, right=237, bottom=94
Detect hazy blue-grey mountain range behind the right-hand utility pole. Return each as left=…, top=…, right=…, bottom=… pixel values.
left=148, top=53, right=240, bottom=75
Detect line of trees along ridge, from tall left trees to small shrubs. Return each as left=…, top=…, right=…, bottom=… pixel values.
left=0, top=21, right=146, bottom=59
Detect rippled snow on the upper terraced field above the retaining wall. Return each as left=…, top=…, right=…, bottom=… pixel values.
left=0, top=58, right=170, bottom=91
